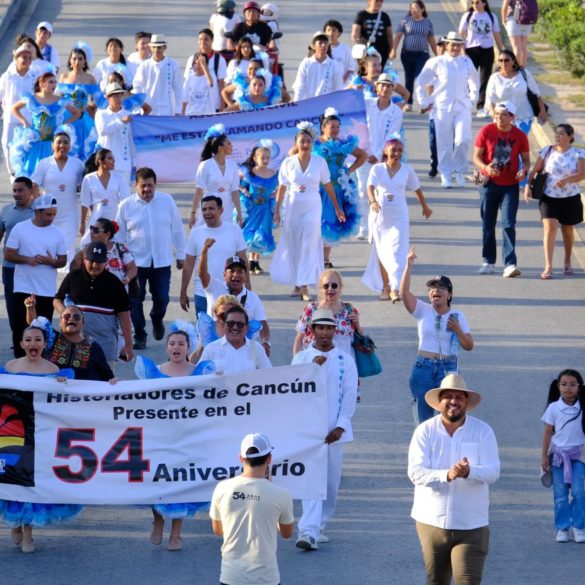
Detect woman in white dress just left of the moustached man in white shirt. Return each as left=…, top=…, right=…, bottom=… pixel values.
left=79, top=148, right=130, bottom=241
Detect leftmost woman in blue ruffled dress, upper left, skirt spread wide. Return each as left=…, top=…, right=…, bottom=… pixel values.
left=9, top=73, right=81, bottom=177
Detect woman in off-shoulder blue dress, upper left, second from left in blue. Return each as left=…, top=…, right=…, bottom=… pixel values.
left=57, top=48, right=101, bottom=161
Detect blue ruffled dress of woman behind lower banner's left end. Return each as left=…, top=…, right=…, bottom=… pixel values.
left=0, top=368, right=83, bottom=528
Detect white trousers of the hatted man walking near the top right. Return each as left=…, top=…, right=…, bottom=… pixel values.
left=434, top=104, right=471, bottom=177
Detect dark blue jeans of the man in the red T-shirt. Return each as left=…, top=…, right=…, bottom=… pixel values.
left=479, top=181, right=520, bottom=266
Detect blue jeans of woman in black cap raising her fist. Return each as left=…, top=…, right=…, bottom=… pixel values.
left=408, top=355, right=457, bottom=425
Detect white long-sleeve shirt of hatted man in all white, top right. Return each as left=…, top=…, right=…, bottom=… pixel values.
left=414, top=55, right=479, bottom=111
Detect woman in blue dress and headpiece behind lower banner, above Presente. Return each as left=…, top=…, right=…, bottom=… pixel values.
left=135, top=321, right=213, bottom=551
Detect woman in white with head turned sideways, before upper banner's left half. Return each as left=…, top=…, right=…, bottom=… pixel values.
left=189, top=124, right=242, bottom=227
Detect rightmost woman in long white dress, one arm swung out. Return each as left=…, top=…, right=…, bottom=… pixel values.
left=362, top=138, right=433, bottom=303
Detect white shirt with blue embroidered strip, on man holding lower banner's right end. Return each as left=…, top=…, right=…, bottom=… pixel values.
left=291, top=344, right=358, bottom=443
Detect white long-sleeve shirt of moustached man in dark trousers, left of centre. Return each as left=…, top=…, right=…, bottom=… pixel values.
left=116, top=191, right=185, bottom=268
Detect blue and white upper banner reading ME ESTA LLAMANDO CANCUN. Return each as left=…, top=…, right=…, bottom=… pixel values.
left=132, top=89, right=368, bottom=183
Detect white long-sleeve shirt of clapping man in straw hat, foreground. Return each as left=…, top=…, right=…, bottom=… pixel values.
left=408, top=414, right=500, bottom=530
